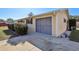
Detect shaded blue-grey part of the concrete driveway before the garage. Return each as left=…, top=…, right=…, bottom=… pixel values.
left=8, top=33, right=79, bottom=51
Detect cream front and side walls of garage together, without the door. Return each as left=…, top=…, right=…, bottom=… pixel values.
left=32, top=10, right=68, bottom=36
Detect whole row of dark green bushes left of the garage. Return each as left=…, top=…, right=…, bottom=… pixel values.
left=8, top=23, right=28, bottom=35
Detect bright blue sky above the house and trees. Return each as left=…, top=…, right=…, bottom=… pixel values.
left=0, top=8, right=79, bottom=20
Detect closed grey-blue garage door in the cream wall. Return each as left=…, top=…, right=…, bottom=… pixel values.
left=36, top=17, right=52, bottom=35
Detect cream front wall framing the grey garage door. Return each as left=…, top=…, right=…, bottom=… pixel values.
left=33, top=14, right=55, bottom=35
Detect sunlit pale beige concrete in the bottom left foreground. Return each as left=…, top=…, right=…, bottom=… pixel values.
left=0, top=40, right=41, bottom=51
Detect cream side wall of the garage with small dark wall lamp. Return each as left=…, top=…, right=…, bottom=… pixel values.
left=56, top=10, right=68, bottom=36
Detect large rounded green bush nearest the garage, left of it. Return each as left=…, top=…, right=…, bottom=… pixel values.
left=14, top=24, right=28, bottom=35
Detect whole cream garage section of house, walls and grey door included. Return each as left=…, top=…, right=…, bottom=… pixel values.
left=32, top=9, right=68, bottom=36
